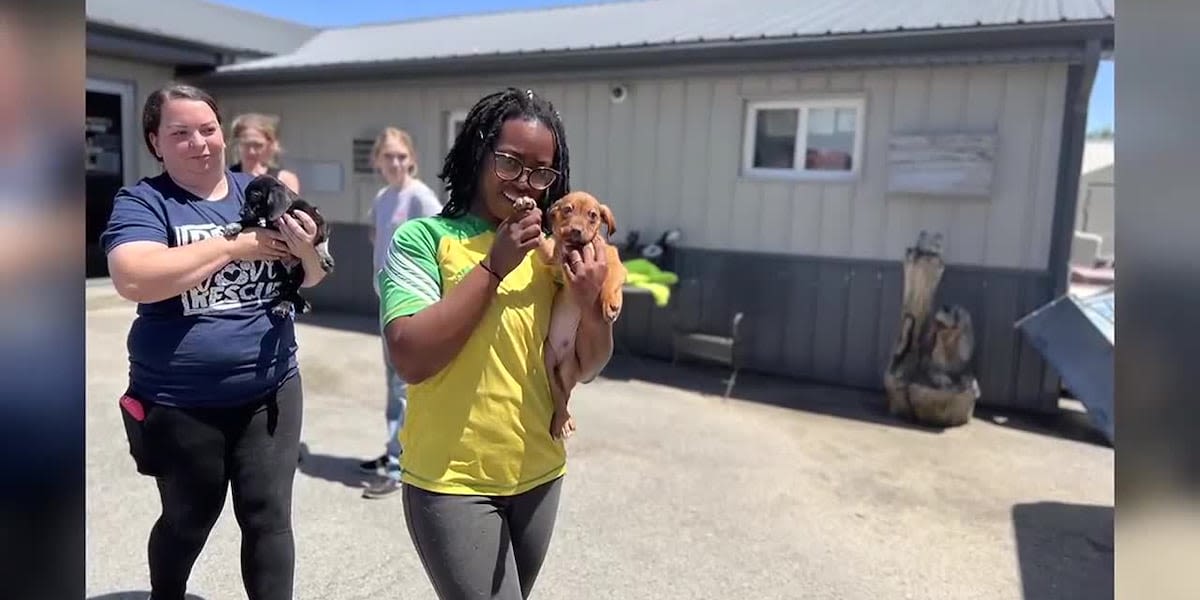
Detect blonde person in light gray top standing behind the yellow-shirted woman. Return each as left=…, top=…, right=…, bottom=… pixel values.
left=360, top=127, right=442, bottom=498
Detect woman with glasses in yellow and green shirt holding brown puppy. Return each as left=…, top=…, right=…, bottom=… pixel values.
left=377, top=89, right=612, bottom=600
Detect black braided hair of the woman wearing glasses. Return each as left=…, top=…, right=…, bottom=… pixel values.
left=438, top=88, right=571, bottom=227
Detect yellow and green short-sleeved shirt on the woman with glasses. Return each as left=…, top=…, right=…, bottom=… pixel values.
left=377, top=215, right=566, bottom=496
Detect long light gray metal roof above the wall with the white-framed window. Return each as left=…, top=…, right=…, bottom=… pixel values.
left=220, top=0, right=1115, bottom=72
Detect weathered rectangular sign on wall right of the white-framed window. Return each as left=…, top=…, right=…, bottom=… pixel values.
left=888, top=133, right=997, bottom=197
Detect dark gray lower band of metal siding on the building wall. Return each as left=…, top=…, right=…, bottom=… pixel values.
left=314, top=223, right=1058, bottom=412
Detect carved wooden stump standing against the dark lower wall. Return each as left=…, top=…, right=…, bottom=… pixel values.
left=883, top=232, right=979, bottom=427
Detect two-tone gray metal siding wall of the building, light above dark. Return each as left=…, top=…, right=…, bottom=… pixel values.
left=211, top=58, right=1067, bottom=410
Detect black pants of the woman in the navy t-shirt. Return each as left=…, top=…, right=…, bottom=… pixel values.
left=145, top=376, right=304, bottom=600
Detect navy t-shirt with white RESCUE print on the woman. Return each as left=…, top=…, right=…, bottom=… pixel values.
left=101, top=172, right=296, bottom=407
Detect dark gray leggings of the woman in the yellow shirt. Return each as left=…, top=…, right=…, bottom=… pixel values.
left=403, top=478, right=563, bottom=600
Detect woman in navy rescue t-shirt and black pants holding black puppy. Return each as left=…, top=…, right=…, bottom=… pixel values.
left=101, top=85, right=324, bottom=600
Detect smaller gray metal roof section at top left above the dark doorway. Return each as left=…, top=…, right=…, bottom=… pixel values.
left=88, top=0, right=318, bottom=54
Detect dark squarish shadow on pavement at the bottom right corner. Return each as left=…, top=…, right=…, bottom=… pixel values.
left=1013, top=502, right=1114, bottom=600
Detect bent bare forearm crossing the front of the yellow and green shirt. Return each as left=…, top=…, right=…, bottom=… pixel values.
left=384, top=266, right=499, bottom=383
